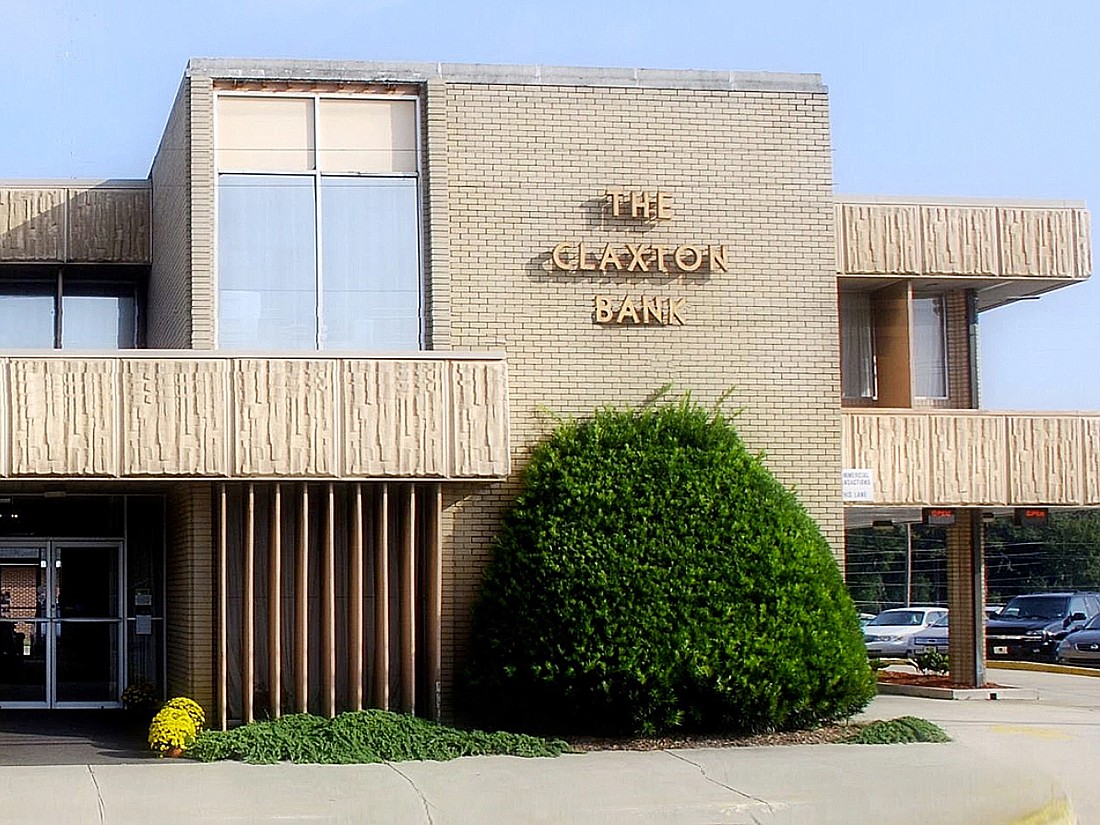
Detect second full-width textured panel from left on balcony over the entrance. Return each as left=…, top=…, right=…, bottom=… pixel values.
left=121, top=359, right=229, bottom=476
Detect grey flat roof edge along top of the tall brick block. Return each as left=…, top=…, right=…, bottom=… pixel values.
left=187, top=57, right=826, bottom=94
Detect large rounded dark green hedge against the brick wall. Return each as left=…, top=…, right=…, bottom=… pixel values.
left=466, top=399, right=875, bottom=733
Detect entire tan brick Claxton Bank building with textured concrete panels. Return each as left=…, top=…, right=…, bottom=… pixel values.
left=0, top=59, right=1086, bottom=724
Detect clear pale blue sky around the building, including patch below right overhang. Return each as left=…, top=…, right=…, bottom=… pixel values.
left=0, top=0, right=1100, bottom=409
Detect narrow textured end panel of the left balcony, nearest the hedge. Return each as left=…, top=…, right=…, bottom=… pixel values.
left=451, top=361, right=510, bottom=477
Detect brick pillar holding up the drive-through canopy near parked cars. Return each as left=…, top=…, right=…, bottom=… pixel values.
left=947, top=509, right=986, bottom=688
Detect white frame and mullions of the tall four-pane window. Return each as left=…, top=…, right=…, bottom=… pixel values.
left=211, top=89, right=428, bottom=353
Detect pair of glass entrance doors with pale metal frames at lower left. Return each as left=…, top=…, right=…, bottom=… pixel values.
left=0, top=541, right=123, bottom=707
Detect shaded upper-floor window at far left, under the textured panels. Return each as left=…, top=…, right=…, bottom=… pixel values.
left=0, top=270, right=139, bottom=350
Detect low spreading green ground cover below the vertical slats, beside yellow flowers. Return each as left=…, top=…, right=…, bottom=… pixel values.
left=187, top=711, right=569, bottom=765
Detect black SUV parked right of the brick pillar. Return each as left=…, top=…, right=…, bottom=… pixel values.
left=986, top=591, right=1100, bottom=659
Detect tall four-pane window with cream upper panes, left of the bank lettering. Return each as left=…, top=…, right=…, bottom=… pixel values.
left=216, top=95, right=422, bottom=351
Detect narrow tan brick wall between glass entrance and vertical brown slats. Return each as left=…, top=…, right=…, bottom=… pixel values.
left=165, top=484, right=217, bottom=718
